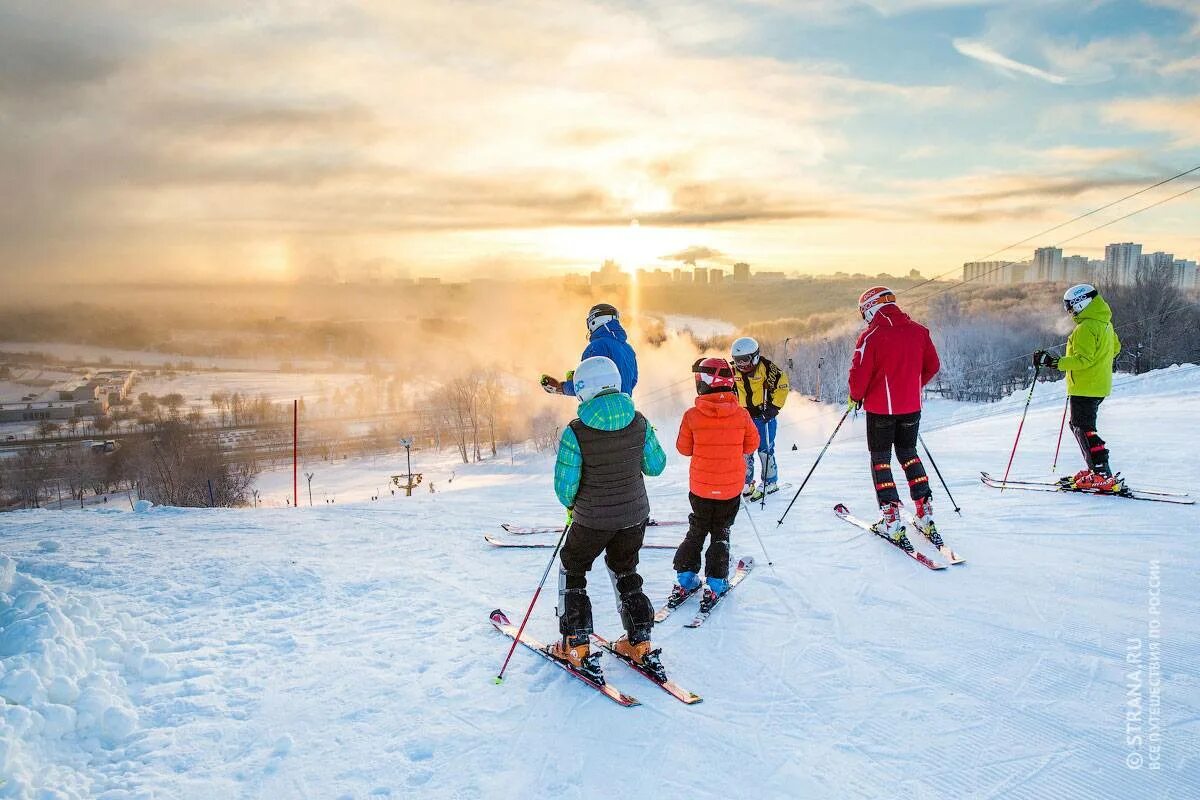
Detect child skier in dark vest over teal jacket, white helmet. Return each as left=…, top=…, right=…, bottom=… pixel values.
left=551, top=356, right=666, bottom=681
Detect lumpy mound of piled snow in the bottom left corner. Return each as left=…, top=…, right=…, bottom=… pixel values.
left=0, top=555, right=147, bottom=800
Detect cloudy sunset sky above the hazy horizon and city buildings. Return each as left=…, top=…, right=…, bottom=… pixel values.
left=0, top=0, right=1200, bottom=282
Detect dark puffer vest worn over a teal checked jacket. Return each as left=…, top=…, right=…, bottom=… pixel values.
left=571, top=411, right=650, bottom=530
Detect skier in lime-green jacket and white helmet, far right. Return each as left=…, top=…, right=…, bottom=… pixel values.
left=1033, top=283, right=1124, bottom=492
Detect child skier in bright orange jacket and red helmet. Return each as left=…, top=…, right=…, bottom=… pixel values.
left=667, top=359, right=758, bottom=610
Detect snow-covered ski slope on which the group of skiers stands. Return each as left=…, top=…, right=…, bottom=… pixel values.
left=0, top=367, right=1200, bottom=800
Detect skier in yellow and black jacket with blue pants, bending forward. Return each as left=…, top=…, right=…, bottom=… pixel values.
left=731, top=336, right=788, bottom=500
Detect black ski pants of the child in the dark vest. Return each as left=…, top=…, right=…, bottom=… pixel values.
left=558, top=522, right=654, bottom=644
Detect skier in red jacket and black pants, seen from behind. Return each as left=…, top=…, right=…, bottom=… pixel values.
left=850, top=287, right=942, bottom=553
